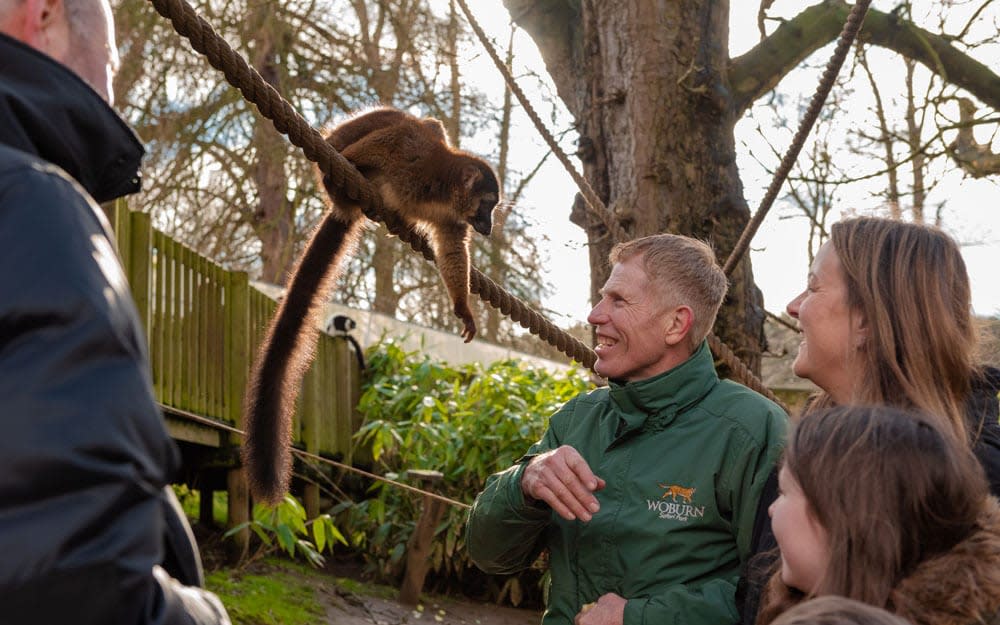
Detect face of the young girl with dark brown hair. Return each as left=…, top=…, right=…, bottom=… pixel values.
left=767, top=466, right=830, bottom=593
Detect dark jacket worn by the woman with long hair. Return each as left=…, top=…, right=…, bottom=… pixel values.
left=736, top=367, right=1000, bottom=625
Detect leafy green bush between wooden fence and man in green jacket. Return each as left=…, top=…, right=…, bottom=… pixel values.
left=342, top=340, right=589, bottom=604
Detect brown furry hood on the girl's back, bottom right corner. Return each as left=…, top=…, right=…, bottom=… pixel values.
left=890, top=497, right=1000, bottom=625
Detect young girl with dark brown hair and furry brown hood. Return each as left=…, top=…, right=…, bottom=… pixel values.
left=757, top=406, right=1000, bottom=625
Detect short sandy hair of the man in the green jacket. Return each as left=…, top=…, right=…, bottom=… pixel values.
left=608, top=234, right=729, bottom=350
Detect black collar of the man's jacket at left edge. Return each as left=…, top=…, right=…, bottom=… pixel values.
left=0, top=34, right=145, bottom=202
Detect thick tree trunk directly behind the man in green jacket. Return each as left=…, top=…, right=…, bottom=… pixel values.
left=506, top=0, right=764, bottom=371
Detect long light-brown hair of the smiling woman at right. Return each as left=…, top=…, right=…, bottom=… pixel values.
left=813, top=217, right=976, bottom=439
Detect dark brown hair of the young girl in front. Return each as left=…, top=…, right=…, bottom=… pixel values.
left=757, top=406, right=988, bottom=625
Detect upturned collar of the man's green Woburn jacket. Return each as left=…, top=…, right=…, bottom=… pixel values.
left=608, top=341, right=719, bottom=434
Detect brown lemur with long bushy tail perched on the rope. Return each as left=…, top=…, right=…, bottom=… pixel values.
left=242, top=107, right=500, bottom=504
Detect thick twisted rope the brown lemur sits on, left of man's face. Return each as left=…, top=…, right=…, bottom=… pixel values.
left=150, top=0, right=597, bottom=369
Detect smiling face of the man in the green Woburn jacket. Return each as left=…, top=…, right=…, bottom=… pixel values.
left=587, top=255, right=677, bottom=382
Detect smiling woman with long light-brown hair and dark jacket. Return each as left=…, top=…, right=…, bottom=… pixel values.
left=740, top=217, right=1000, bottom=624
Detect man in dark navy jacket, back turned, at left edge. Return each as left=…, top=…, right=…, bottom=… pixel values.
left=0, top=0, right=229, bottom=625
